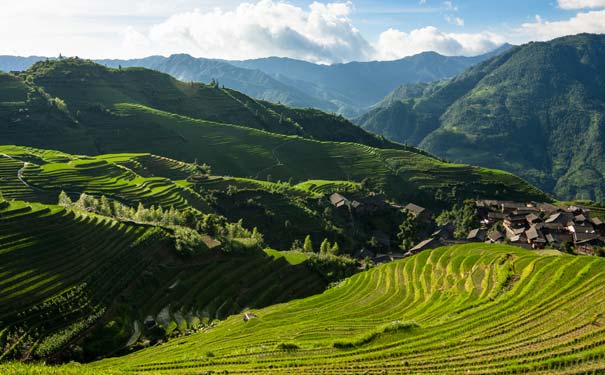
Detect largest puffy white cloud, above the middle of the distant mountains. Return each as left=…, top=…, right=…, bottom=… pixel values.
left=124, top=0, right=373, bottom=62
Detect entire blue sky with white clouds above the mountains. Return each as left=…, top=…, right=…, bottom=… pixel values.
left=0, top=0, right=605, bottom=64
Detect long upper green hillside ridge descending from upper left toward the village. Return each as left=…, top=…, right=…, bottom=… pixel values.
left=0, top=60, right=548, bottom=210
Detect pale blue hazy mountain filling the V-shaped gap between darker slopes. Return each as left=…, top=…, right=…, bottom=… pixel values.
left=230, top=45, right=510, bottom=117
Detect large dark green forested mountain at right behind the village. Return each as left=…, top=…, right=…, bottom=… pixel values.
left=356, top=34, right=605, bottom=201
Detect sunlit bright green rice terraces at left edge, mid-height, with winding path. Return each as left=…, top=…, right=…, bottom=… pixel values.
left=0, top=146, right=207, bottom=209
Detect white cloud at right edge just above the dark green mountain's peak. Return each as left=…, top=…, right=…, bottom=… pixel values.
left=516, top=10, right=605, bottom=41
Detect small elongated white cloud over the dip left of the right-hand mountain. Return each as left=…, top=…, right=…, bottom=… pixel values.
left=376, top=26, right=505, bottom=60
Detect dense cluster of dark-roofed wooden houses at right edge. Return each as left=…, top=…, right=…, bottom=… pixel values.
left=467, top=200, right=605, bottom=255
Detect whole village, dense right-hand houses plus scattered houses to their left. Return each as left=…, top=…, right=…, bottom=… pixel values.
left=330, top=193, right=605, bottom=264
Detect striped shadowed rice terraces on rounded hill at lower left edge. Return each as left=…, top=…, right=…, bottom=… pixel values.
left=0, top=201, right=163, bottom=359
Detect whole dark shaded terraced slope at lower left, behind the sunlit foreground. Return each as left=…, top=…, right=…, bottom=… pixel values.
left=0, top=201, right=326, bottom=362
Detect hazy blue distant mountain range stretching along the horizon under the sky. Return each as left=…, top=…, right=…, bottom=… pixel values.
left=0, top=45, right=511, bottom=117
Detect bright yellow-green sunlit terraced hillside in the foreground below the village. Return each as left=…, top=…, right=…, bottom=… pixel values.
left=81, top=244, right=605, bottom=374
